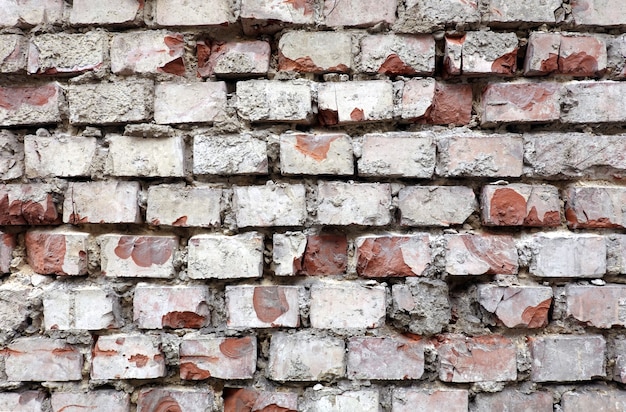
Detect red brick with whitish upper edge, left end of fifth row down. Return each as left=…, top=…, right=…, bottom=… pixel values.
left=0, top=183, right=61, bottom=225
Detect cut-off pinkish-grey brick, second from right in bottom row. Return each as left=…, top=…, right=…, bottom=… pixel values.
left=470, top=389, right=552, bottom=412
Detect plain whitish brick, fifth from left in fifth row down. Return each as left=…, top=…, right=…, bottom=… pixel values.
left=317, top=182, right=391, bottom=226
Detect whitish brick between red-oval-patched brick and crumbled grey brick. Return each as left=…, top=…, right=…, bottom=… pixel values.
left=309, top=282, right=386, bottom=329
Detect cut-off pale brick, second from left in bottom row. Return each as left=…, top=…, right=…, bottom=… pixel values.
left=50, top=389, right=130, bottom=412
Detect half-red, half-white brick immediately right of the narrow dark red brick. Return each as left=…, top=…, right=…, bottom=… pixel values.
left=354, top=234, right=432, bottom=278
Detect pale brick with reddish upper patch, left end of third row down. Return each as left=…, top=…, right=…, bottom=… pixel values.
left=0, top=83, right=63, bottom=126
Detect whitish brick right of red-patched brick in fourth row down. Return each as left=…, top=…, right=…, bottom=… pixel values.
left=357, top=132, right=436, bottom=178
